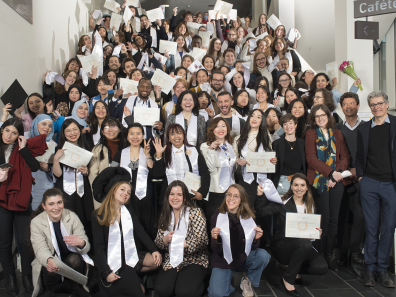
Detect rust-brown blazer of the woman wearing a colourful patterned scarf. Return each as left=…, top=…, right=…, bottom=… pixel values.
left=305, top=129, right=351, bottom=186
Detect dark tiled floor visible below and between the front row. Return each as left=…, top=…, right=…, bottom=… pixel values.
left=0, top=261, right=396, bottom=297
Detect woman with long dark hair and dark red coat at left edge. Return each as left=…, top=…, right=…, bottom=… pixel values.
left=0, top=118, right=48, bottom=296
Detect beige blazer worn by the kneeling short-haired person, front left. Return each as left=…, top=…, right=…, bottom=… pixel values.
left=30, top=208, right=91, bottom=297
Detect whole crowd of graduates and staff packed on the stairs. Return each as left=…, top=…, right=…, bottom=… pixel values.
left=0, top=1, right=396, bottom=297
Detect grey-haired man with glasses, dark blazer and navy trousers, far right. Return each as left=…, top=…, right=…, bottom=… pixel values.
left=356, top=91, right=396, bottom=288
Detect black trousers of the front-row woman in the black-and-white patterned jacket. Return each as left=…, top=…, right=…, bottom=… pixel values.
left=154, top=264, right=206, bottom=297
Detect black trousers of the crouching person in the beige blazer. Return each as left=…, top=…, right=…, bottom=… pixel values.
left=41, top=253, right=85, bottom=292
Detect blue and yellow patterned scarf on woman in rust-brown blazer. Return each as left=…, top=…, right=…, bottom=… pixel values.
left=313, top=128, right=336, bottom=194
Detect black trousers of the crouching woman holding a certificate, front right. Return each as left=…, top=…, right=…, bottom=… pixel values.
left=271, top=238, right=328, bottom=285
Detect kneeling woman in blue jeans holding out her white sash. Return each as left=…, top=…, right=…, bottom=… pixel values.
left=208, top=184, right=271, bottom=297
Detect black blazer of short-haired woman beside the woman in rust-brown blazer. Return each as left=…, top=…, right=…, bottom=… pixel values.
left=270, top=135, right=307, bottom=188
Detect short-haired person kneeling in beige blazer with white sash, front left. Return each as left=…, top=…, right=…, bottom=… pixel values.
left=30, top=188, right=93, bottom=297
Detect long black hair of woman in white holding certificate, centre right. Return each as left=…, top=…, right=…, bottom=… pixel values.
left=237, top=109, right=272, bottom=157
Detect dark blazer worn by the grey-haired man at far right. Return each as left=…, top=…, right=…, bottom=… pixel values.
left=356, top=114, right=396, bottom=179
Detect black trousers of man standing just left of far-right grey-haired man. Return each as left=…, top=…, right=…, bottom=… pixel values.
left=337, top=183, right=365, bottom=253
